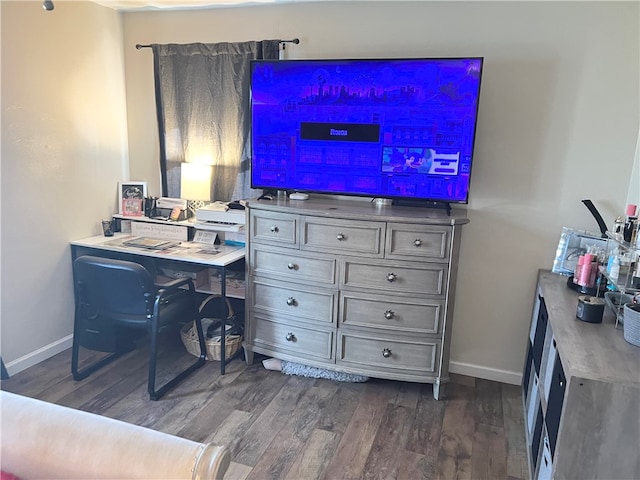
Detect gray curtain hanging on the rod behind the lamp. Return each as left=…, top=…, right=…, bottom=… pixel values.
left=152, top=40, right=279, bottom=201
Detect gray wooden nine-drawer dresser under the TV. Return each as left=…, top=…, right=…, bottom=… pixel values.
left=245, top=198, right=468, bottom=399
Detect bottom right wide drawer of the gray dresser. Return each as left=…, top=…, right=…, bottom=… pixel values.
left=336, top=329, right=440, bottom=375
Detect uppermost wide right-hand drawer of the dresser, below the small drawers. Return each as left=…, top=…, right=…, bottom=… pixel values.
left=341, top=259, right=449, bottom=295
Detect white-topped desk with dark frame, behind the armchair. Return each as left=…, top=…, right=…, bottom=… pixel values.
left=71, top=233, right=245, bottom=375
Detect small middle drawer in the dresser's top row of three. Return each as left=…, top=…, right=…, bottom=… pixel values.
left=300, top=217, right=385, bottom=258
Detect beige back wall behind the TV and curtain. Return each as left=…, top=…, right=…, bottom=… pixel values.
left=124, top=1, right=640, bottom=383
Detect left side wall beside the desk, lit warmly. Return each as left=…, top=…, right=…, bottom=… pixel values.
left=0, top=0, right=129, bottom=374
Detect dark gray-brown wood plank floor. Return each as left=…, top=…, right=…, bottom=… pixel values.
left=1, top=334, right=528, bottom=480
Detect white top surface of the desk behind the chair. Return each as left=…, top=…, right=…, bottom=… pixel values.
left=71, top=233, right=245, bottom=267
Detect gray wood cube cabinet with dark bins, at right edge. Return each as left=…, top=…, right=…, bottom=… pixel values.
left=522, top=270, right=640, bottom=480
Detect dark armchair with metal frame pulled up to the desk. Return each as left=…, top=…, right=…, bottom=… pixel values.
left=71, top=255, right=207, bottom=400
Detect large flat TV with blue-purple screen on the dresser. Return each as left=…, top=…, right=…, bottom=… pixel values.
left=251, top=58, right=483, bottom=203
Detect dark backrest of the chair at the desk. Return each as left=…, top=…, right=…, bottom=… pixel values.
left=73, top=255, right=158, bottom=320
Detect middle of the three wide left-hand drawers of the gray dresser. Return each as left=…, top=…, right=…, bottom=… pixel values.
left=251, top=277, right=337, bottom=324
